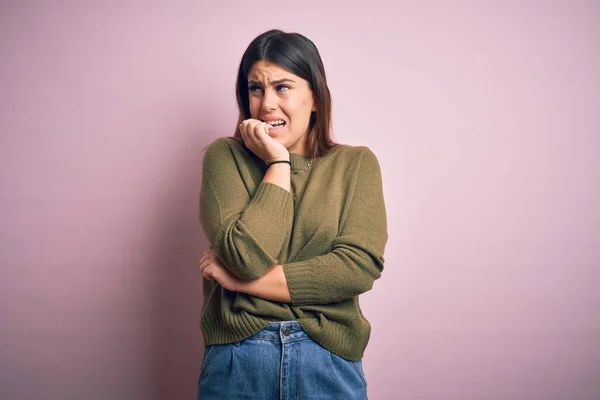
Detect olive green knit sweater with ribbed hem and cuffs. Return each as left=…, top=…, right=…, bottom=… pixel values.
left=200, top=138, right=387, bottom=361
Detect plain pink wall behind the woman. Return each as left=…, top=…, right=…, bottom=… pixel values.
left=0, top=0, right=600, bottom=400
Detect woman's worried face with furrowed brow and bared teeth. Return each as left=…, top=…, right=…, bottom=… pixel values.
left=248, top=60, right=316, bottom=155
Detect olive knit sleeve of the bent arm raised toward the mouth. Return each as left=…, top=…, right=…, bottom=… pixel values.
left=200, top=139, right=294, bottom=280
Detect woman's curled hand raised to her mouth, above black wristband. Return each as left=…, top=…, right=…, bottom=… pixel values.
left=239, top=118, right=290, bottom=163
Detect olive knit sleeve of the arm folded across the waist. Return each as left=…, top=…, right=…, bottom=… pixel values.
left=283, top=148, right=388, bottom=305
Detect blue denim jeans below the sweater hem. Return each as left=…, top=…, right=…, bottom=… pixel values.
left=198, top=321, right=367, bottom=400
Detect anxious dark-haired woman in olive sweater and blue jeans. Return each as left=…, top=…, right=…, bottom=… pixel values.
left=198, top=30, right=387, bottom=400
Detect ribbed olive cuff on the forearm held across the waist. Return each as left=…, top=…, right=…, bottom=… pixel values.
left=282, top=261, right=320, bottom=305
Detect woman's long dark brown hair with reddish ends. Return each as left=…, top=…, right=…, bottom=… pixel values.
left=234, top=29, right=337, bottom=158
